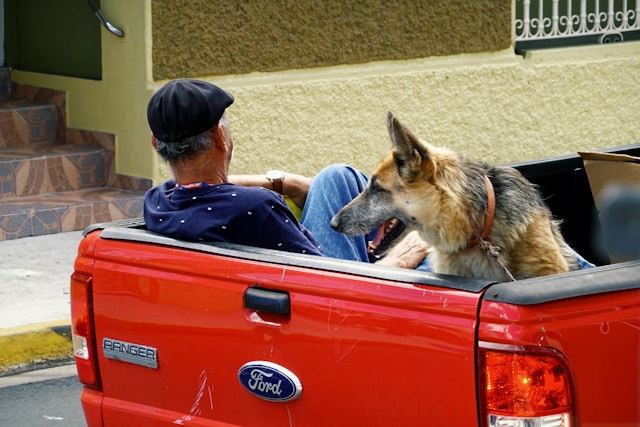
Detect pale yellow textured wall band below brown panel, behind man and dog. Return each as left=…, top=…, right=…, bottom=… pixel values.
left=216, top=43, right=640, bottom=173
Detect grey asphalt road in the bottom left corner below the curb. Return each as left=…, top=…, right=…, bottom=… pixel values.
left=0, top=365, right=87, bottom=427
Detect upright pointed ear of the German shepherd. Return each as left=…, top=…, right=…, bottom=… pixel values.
left=387, top=111, right=435, bottom=182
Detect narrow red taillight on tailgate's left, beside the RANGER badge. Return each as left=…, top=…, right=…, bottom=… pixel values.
left=71, top=272, right=100, bottom=388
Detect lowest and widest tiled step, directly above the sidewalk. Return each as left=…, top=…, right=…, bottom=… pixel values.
left=0, top=187, right=144, bottom=241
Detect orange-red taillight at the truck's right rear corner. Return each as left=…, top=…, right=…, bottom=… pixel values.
left=479, top=342, right=574, bottom=427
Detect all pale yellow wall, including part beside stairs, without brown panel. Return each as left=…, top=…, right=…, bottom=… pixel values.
left=13, top=0, right=640, bottom=182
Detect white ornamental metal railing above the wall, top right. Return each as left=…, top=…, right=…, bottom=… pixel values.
left=515, top=0, right=640, bottom=43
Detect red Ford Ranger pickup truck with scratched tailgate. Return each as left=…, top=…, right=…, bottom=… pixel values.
left=71, top=144, right=640, bottom=427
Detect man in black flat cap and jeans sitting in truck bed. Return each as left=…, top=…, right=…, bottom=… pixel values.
left=144, top=79, right=426, bottom=268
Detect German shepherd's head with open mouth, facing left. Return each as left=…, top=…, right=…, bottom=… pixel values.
left=331, top=112, right=470, bottom=254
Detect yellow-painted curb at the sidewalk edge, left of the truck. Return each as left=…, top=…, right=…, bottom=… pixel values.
left=0, top=319, right=73, bottom=377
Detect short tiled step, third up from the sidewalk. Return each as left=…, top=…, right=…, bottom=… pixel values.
left=0, top=99, right=58, bottom=148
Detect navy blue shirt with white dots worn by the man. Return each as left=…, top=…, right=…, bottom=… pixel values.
left=144, top=180, right=322, bottom=255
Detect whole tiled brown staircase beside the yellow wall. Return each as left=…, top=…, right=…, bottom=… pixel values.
left=0, top=69, right=151, bottom=241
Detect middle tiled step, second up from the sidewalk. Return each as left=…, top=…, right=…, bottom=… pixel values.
left=0, top=141, right=106, bottom=201
